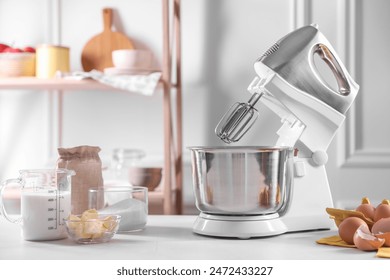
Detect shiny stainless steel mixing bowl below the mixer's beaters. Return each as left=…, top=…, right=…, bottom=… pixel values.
left=189, top=146, right=293, bottom=216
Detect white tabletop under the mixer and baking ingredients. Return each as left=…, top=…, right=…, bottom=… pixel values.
left=0, top=215, right=379, bottom=260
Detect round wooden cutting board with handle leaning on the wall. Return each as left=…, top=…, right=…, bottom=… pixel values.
left=81, top=8, right=134, bottom=71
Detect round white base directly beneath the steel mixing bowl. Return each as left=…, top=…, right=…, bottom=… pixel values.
left=193, top=213, right=287, bottom=239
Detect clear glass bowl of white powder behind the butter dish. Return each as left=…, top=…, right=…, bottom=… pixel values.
left=88, top=186, right=148, bottom=233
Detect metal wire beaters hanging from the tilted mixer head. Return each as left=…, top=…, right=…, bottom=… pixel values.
left=215, top=92, right=263, bottom=144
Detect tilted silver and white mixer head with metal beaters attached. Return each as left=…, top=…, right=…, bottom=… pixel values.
left=215, top=24, right=359, bottom=148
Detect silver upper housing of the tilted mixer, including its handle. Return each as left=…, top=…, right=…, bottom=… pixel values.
left=254, top=24, right=359, bottom=114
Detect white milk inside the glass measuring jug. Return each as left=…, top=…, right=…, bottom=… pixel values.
left=21, top=189, right=71, bottom=240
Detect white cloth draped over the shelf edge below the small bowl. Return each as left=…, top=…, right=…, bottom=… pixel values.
left=64, top=70, right=161, bottom=96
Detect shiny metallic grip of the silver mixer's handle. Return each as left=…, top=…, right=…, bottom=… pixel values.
left=315, top=44, right=351, bottom=96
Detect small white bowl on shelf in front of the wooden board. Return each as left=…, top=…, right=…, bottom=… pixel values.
left=112, top=49, right=153, bottom=70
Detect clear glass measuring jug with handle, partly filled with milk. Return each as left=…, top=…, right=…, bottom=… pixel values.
left=0, top=168, right=75, bottom=241
